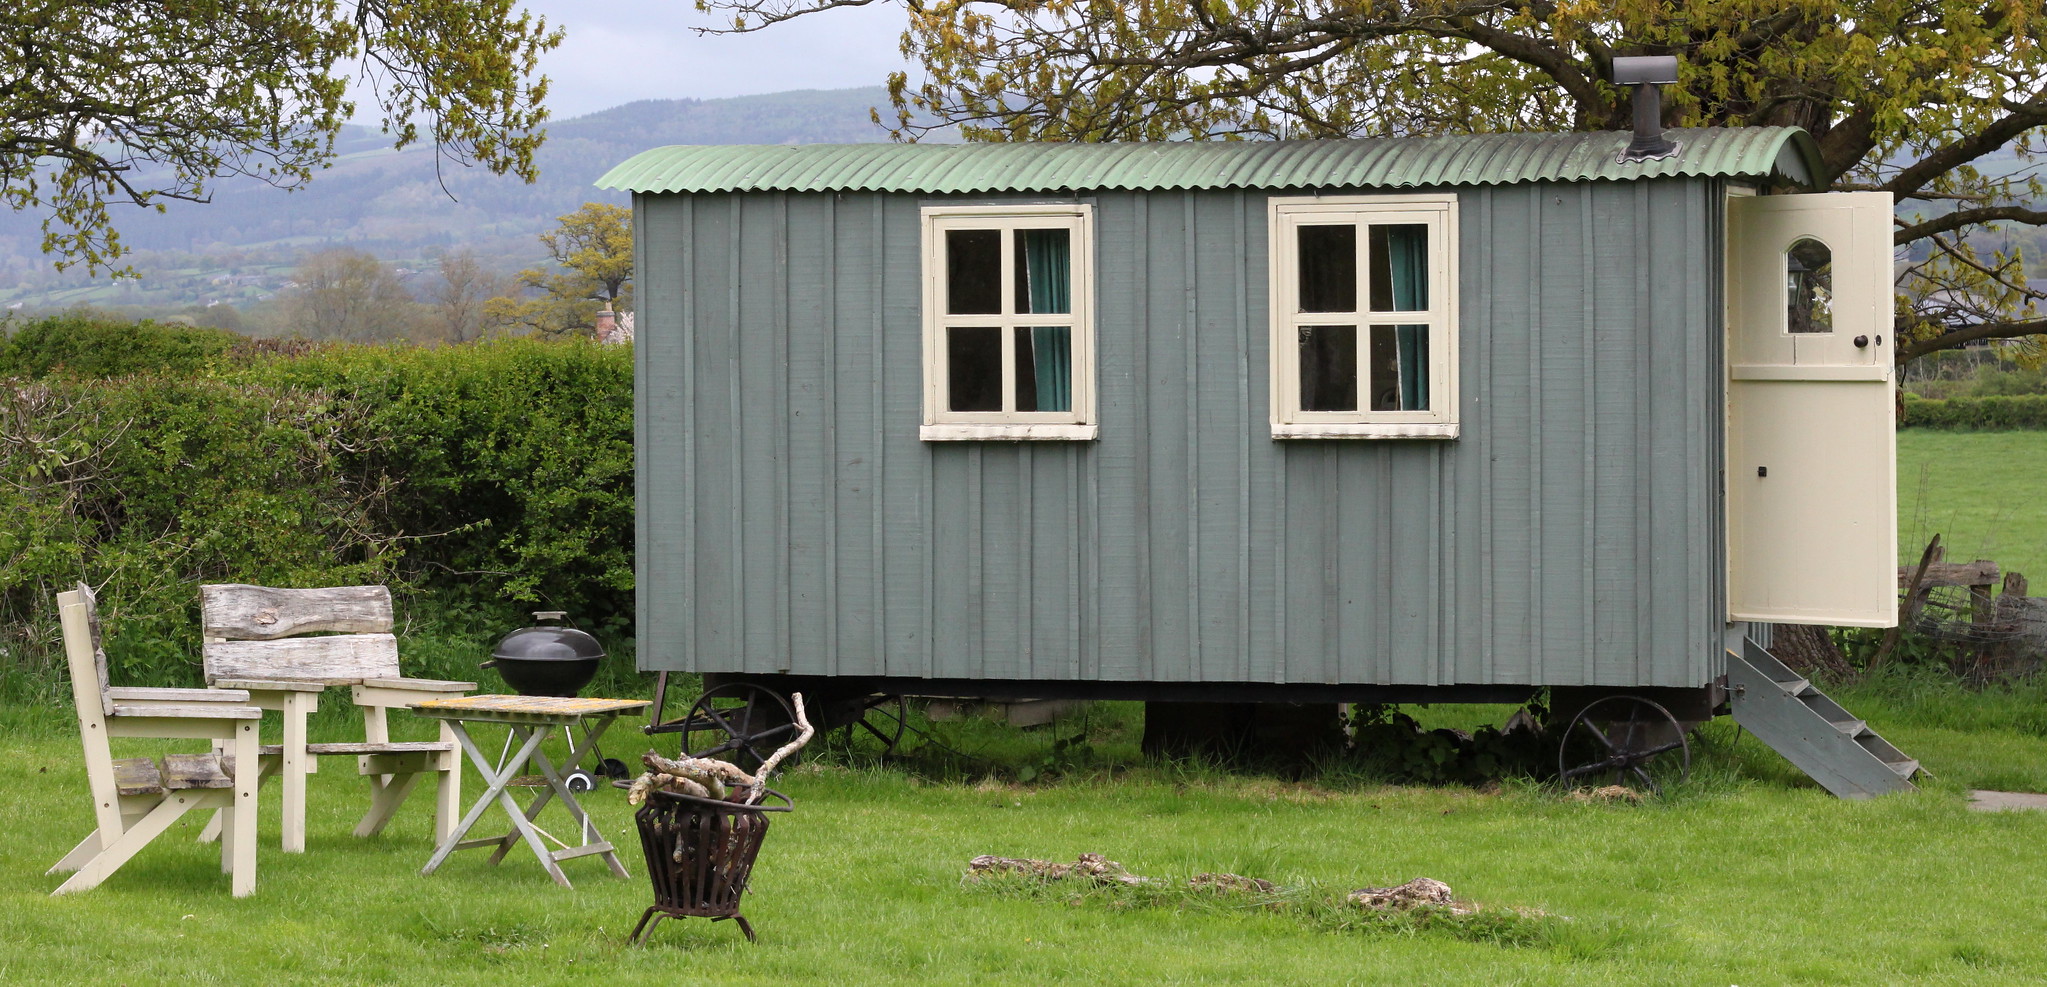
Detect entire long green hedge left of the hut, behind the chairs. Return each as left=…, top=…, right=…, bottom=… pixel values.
left=0, top=319, right=633, bottom=696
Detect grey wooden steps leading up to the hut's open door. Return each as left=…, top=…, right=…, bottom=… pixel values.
left=1728, top=639, right=1920, bottom=799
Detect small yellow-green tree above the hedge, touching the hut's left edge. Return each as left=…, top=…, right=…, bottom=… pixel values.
left=483, top=203, right=633, bottom=336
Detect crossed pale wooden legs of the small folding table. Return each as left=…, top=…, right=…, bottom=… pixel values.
left=420, top=713, right=626, bottom=887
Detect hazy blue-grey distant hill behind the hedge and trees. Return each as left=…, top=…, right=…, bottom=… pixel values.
left=0, top=86, right=888, bottom=307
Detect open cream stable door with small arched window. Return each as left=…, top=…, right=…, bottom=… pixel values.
left=1726, top=192, right=1898, bottom=627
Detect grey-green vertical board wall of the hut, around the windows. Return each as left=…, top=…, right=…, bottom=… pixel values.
left=639, top=180, right=1722, bottom=686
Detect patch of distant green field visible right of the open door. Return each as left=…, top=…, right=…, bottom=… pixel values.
left=1898, top=428, right=2047, bottom=577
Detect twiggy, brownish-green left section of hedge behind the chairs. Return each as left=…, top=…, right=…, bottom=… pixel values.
left=0, top=377, right=397, bottom=684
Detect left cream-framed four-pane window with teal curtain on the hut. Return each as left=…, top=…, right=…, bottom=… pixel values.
left=919, top=203, right=1095, bottom=440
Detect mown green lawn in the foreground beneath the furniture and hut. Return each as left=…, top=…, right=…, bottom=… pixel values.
left=12, top=680, right=2047, bottom=985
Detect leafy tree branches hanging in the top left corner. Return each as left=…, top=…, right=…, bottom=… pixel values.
left=0, top=0, right=561, bottom=270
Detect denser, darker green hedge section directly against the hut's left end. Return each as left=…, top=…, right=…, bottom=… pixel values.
left=239, top=340, right=633, bottom=635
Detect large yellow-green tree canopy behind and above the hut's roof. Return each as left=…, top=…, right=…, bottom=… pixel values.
left=700, top=0, right=2047, bottom=360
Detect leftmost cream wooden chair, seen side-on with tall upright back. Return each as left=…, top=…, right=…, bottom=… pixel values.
left=49, top=584, right=264, bottom=897
